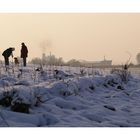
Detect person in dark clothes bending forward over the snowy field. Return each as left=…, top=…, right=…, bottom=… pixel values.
left=2, top=48, right=15, bottom=66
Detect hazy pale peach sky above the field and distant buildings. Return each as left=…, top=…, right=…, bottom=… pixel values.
left=0, top=13, right=140, bottom=64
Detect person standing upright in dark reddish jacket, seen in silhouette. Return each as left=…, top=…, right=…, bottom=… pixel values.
left=21, top=43, right=28, bottom=67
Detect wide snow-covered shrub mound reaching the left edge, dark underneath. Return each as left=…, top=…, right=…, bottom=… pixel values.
left=0, top=86, right=43, bottom=113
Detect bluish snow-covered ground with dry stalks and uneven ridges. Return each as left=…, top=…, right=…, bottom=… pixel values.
left=0, top=66, right=140, bottom=127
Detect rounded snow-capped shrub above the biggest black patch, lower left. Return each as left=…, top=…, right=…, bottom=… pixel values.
left=11, top=86, right=46, bottom=113
